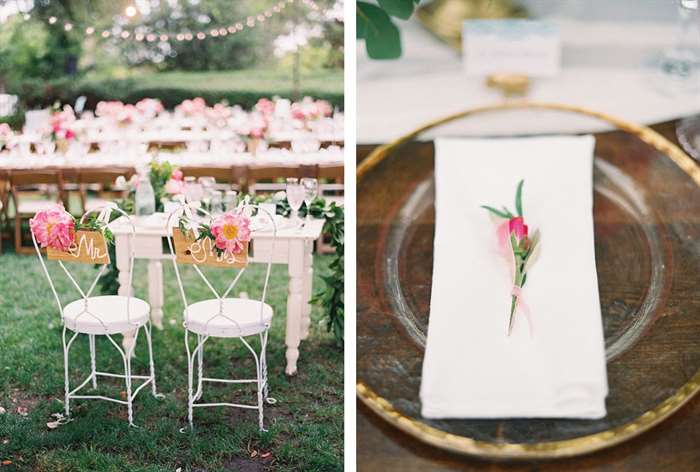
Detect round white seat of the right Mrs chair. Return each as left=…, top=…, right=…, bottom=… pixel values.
left=185, top=298, right=272, bottom=338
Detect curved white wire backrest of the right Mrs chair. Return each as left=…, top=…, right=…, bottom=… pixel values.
left=167, top=202, right=277, bottom=332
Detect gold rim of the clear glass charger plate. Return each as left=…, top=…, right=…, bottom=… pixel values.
left=356, top=101, right=700, bottom=459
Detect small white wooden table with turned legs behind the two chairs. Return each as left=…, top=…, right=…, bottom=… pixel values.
left=110, top=215, right=325, bottom=375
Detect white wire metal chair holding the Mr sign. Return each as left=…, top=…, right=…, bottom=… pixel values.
left=32, top=206, right=163, bottom=426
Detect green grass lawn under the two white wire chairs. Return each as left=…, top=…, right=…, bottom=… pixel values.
left=0, top=254, right=343, bottom=471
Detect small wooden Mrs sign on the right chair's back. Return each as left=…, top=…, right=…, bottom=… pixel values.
left=173, top=229, right=248, bottom=268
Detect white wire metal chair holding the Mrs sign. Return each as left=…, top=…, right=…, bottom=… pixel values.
left=168, top=204, right=277, bottom=431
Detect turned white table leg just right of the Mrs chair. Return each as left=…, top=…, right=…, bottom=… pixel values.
left=285, top=240, right=304, bottom=375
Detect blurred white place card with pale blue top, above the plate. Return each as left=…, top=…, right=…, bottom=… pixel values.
left=462, top=19, right=561, bottom=77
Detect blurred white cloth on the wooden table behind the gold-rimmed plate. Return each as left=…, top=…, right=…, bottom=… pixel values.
left=357, top=12, right=700, bottom=143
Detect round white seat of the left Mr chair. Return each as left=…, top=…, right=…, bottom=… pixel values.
left=63, top=295, right=151, bottom=334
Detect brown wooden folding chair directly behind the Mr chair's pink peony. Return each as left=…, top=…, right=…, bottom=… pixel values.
left=8, top=169, right=65, bottom=254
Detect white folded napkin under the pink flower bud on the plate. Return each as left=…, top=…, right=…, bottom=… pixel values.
left=420, top=136, right=608, bottom=418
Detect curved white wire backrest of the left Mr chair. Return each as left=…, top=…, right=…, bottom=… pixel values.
left=32, top=205, right=136, bottom=331
